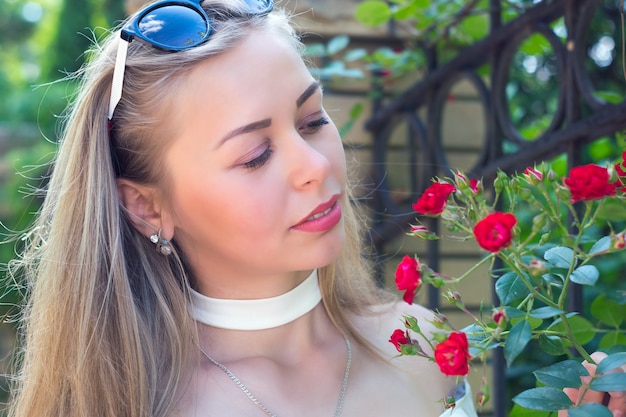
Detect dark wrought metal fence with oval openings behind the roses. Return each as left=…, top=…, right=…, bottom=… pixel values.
left=358, top=0, right=626, bottom=417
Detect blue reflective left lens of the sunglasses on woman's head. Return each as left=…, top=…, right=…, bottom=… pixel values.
left=137, top=4, right=209, bottom=50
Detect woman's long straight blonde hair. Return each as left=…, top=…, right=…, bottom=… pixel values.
left=9, top=1, right=378, bottom=417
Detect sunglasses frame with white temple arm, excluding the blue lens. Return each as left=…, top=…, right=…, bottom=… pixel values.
left=107, top=0, right=274, bottom=119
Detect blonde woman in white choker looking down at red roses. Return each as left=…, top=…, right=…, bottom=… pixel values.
left=10, top=0, right=616, bottom=417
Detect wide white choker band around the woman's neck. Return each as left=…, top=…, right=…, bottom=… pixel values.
left=191, top=270, right=322, bottom=330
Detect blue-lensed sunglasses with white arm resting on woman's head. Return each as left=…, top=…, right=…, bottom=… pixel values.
left=108, top=0, right=274, bottom=121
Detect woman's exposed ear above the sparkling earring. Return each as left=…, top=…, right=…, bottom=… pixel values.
left=117, top=178, right=173, bottom=239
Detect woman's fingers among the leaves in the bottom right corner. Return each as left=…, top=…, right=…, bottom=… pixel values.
left=559, top=352, right=626, bottom=417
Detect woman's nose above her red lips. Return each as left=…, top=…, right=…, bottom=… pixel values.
left=285, top=133, right=334, bottom=188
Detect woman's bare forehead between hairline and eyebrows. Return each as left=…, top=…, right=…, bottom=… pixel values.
left=165, top=30, right=313, bottom=134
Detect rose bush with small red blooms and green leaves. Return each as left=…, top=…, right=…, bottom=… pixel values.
left=390, top=157, right=626, bottom=417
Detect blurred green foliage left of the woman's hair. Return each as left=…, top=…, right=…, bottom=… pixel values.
left=0, top=0, right=124, bottom=264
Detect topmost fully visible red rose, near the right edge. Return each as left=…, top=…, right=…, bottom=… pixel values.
left=563, top=164, right=617, bottom=203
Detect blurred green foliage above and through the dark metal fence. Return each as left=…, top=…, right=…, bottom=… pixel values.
left=304, top=0, right=626, bottom=158
